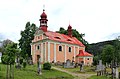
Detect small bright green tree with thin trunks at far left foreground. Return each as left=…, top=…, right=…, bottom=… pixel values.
left=2, top=43, right=18, bottom=79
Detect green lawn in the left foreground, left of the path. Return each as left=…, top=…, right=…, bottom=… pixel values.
left=0, top=64, right=73, bottom=79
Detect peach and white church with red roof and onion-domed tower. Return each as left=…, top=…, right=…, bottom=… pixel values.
left=31, top=10, right=93, bottom=65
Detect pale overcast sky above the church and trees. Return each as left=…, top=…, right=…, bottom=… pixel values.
left=0, top=0, right=120, bottom=43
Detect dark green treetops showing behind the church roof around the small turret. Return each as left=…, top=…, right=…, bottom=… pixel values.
left=57, top=27, right=88, bottom=46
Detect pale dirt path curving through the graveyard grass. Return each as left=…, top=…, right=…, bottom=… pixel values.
left=52, top=67, right=96, bottom=79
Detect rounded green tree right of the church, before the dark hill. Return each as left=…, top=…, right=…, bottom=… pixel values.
left=101, top=45, right=115, bottom=64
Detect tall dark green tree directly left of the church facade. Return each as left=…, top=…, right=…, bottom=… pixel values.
left=19, top=22, right=37, bottom=58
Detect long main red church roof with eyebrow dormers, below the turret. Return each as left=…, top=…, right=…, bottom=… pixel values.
left=45, top=31, right=84, bottom=46
